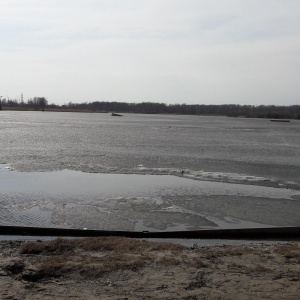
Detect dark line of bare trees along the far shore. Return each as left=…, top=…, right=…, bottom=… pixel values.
left=0, top=97, right=300, bottom=119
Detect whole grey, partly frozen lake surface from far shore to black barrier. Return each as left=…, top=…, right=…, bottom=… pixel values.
left=0, top=111, right=300, bottom=231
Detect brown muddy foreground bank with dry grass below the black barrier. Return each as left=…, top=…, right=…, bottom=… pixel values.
left=0, top=237, right=300, bottom=300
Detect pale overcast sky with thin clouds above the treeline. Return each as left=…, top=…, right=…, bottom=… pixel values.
left=0, top=0, right=300, bottom=105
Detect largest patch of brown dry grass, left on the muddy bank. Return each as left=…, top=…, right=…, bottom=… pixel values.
left=20, top=237, right=186, bottom=281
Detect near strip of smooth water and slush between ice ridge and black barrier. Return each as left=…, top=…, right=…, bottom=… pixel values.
left=0, top=165, right=300, bottom=231
